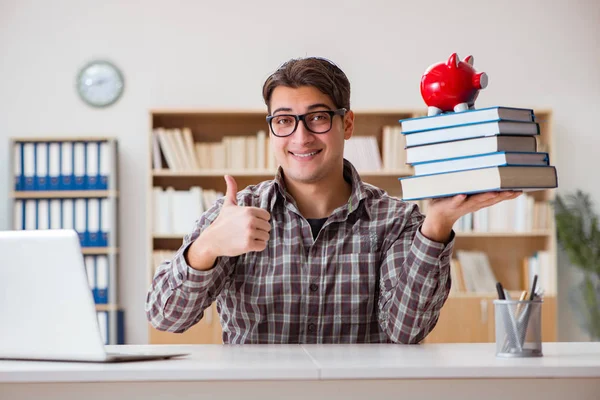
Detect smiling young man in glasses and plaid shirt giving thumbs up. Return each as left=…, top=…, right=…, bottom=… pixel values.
left=146, top=58, right=518, bottom=343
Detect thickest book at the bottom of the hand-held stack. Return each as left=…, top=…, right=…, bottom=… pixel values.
left=399, top=166, right=558, bottom=200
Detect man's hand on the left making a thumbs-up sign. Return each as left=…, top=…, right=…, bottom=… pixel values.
left=202, top=175, right=271, bottom=257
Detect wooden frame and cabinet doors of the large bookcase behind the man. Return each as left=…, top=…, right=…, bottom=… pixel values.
left=148, top=109, right=556, bottom=344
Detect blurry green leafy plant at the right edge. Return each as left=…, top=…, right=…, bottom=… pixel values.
left=554, top=190, right=600, bottom=340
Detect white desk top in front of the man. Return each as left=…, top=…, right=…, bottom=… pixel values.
left=0, top=343, right=600, bottom=400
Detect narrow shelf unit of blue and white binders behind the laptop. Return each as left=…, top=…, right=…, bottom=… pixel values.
left=9, top=136, right=124, bottom=344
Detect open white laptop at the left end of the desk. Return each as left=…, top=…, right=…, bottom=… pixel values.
left=0, top=230, right=187, bottom=362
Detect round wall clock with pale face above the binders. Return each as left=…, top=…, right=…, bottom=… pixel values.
left=77, top=61, right=125, bottom=107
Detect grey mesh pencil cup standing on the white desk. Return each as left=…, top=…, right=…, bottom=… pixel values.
left=494, top=300, right=543, bottom=357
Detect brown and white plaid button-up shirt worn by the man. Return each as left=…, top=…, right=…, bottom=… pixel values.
left=146, top=160, right=454, bottom=344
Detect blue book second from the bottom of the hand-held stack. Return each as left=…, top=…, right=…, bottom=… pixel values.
left=413, top=151, right=549, bottom=175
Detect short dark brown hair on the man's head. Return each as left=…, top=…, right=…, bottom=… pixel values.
left=263, top=57, right=350, bottom=113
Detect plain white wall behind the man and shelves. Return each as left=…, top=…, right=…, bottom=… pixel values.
left=0, top=0, right=600, bottom=343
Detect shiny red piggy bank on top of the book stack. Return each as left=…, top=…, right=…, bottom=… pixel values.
left=421, top=53, right=488, bottom=115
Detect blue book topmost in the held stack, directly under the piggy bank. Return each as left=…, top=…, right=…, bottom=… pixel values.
left=399, top=106, right=535, bottom=133
